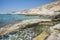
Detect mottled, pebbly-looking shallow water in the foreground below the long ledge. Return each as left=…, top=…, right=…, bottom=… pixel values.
left=0, top=29, right=36, bottom=40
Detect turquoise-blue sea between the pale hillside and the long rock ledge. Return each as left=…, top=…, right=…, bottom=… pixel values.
left=0, top=14, right=40, bottom=27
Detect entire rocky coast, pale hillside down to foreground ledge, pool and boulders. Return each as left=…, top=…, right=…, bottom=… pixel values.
left=0, top=1, right=60, bottom=40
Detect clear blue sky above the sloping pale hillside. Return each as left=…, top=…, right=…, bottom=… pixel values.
left=0, top=0, right=54, bottom=13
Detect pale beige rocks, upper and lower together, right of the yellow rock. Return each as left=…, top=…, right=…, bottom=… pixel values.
left=46, top=24, right=60, bottom=40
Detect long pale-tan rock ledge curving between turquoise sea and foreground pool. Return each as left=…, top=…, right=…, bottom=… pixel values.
left=0, top=19, right=51, bottom=35
